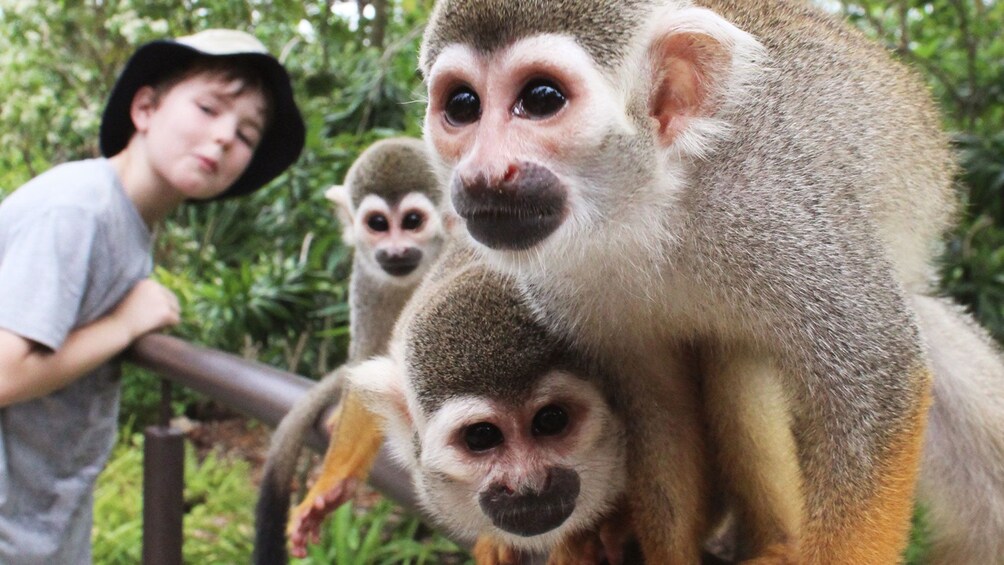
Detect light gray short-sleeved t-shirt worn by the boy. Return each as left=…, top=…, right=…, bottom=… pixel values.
left=0, top=159, right=153, bottom=565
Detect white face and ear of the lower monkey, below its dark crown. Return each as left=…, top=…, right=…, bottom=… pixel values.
left=349, top=357, right=625, bottom=552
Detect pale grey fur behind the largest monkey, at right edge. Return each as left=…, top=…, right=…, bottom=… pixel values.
left=914, top=296, right=1004, bottom=565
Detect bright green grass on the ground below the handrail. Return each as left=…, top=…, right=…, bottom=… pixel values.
left=91, top=434, right=470, bottom=565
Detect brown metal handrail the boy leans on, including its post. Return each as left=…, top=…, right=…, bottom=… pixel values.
left=126, top=334, right=419, bottom=565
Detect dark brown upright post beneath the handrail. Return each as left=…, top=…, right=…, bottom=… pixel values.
left=143, top=380, right=185, bottom=565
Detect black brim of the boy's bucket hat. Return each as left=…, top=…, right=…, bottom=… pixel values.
left=100, top=40, right=306, bottom=200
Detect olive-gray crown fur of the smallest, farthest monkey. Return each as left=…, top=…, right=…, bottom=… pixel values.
left=345, top=137, right=442, bottom=208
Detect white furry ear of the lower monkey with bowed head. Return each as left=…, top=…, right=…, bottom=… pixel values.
left=346, top=356, right=414, bottom=430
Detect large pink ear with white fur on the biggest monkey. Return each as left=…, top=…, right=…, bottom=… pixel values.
left=649, top=8, right=763, bottom=150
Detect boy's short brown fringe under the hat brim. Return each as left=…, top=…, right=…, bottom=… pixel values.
left=151, top=55, right=275, bottom=125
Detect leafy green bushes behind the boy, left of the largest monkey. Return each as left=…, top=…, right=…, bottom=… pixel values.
left=0, top=0, right=427, bottom=422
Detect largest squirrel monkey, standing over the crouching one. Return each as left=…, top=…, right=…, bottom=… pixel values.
left=420, top=0, right=956, bottom=564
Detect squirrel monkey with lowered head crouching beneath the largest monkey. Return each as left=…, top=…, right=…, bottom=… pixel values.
left=347, top=250, right=630, bottom=565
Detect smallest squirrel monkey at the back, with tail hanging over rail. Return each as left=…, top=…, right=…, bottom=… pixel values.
left=254, top=137, right=447, bottom=565
